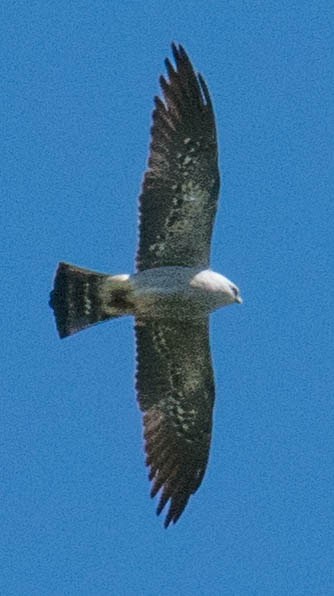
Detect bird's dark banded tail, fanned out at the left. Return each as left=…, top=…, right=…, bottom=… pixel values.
left=49, top=263, right=133, bottom=337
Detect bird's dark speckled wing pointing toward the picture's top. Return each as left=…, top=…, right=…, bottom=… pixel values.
left=137, top=44, right=219, bottom=271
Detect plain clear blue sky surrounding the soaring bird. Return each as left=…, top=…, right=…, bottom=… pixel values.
left=0, top=0, right=334, bottom=596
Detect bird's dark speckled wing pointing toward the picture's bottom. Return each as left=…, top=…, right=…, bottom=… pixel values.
left=136, top=318, right=214, bottom=527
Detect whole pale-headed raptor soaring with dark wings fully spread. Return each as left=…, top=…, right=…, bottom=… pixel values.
left=50, top=44, right=242, bottom=527
